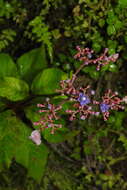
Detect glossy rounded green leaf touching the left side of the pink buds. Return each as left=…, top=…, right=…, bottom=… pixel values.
left=31, top=68, right=67, bottom=94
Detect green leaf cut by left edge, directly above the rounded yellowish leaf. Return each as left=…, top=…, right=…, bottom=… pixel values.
left=0, top=53, right=18, bottom=77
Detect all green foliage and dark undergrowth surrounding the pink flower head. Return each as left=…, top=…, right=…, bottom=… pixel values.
left=0, top=0, right=127, bottom=190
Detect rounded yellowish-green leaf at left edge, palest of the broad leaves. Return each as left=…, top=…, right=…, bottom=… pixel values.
left=0, top=77, right=29, bottom=101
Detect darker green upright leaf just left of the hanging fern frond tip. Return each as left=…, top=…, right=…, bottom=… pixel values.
left=17, top=46, right=47, bottom=83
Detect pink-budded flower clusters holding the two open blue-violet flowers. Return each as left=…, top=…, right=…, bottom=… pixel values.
left=60, top=80, right=124, bottom=121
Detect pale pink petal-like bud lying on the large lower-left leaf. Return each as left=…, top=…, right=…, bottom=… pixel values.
left=29, top=130, right=41, bottom=145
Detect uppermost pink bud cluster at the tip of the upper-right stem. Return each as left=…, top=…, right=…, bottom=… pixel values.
left=74, top=46, right=119, bottom=71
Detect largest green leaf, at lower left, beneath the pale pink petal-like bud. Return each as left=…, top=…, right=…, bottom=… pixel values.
left=0, top=111, right=49, bottom=182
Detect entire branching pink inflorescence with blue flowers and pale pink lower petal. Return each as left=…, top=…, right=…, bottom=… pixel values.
left=29, top=46, right=127, bottom=145
